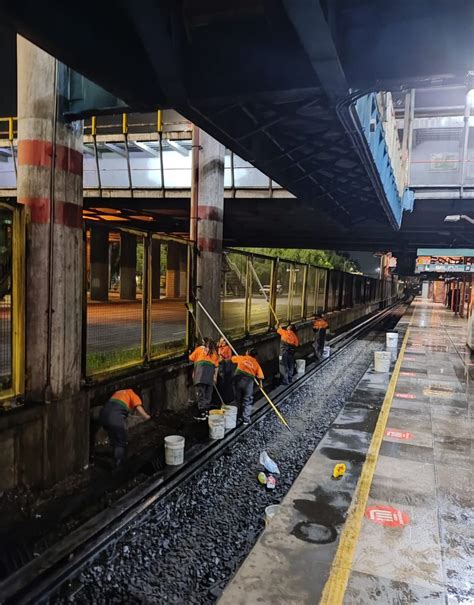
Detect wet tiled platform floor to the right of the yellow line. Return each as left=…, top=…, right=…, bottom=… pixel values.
left=344, top=300, right=474, bottom=605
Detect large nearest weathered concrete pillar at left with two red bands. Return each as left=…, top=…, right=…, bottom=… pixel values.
left=17, top=37, right=89, bottom=482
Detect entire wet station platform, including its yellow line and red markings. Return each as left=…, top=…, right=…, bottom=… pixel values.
left=219, top=299, right=474, bottom=605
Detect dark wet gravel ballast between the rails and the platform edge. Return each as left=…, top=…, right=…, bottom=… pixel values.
left=56, top=336, right=388, bottom=604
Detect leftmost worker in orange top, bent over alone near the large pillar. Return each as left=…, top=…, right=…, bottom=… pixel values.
left=99, top=389, right=151, bottom=467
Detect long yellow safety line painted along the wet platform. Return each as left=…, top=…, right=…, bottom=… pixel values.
left=319, top=324, right=413, bottom=605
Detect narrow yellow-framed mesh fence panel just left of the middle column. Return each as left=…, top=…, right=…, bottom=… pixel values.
left=151, top=238, right=188, bottom=356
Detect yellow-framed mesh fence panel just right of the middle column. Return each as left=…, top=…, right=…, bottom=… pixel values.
left=221, top=252, right=247, bottom=337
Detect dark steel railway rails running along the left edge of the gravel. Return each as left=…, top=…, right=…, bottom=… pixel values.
left=0, top=303, right=404, bottom=604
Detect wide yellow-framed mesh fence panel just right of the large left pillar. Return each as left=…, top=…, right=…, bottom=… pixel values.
left=86, top=225, right=144, bottom=375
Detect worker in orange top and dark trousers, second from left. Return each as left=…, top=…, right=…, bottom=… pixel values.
left=189, top=338, right=219, bottom=420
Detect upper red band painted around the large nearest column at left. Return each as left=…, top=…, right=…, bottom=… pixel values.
left=18, top=140, right=82, bottom=176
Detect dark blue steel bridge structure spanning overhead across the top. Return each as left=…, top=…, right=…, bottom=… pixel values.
left=0, top=0, right=473, bottom=251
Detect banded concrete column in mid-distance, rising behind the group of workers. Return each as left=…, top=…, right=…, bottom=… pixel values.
left=193, top=130, right=225, bottom=338
